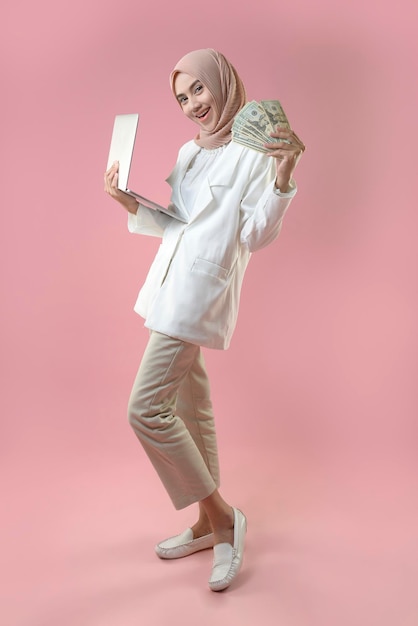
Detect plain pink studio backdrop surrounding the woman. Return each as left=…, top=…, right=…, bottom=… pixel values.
left=0, top=0, right=418, bottom=626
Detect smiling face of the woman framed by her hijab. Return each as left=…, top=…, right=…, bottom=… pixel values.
left=174, top=72, right=218, bottom=130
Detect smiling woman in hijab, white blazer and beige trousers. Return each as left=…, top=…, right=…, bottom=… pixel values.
left=105, top=49, right=305, bottom=591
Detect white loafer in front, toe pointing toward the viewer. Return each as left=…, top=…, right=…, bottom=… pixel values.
left=209, top=509, right=247, bottom=591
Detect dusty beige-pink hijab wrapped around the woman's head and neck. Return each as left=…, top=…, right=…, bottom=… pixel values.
left=170, top=48, right=246, bottom=149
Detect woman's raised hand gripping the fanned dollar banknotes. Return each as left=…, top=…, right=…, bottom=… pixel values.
left=264, top=126, right=305, bottom=193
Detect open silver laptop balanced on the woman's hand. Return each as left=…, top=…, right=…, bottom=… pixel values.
left=107, top=113, right=187, bottom=223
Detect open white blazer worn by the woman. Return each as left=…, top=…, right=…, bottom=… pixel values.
left=128, top=141, right=296, bottom=350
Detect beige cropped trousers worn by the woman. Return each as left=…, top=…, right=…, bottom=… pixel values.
left=128, top=332, right=219, bottom=509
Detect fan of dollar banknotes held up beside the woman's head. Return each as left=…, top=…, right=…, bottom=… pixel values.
left=232, top=100, right=290, bottom=152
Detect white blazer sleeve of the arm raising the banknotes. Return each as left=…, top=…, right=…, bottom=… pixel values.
left=241, top=153, right=297, bottom=252
